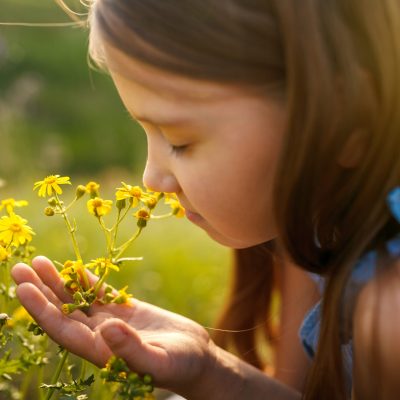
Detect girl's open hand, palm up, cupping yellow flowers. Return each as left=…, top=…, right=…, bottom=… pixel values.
left=12, top=257, right=215, bottom=393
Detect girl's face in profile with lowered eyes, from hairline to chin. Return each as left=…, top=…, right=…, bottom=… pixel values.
left=106, top=47, right=285, bottom=248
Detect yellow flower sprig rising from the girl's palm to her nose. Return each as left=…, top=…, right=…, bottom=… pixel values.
left=33, top=175, right=184, bottom=314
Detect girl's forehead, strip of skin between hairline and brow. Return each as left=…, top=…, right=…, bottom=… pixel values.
left=104, top=46, right=244, bottom=102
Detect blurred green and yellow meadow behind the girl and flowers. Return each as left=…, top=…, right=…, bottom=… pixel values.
left=0, top=0, right=230, bottom=326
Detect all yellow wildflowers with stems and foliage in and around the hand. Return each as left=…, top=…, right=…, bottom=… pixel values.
left=0, top=175, right=184, bottom=400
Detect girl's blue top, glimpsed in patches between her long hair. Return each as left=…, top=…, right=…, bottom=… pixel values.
left=299, top=187, right=400, bottom=392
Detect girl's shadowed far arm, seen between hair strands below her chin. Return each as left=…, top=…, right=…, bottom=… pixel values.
left=274, top=259, right=321, bottom=391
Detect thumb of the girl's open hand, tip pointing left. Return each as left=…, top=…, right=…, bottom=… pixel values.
left=99, top=318, right=168, bottom=377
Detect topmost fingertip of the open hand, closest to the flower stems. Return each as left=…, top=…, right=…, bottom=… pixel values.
left=32, top=256, right=72, bottom=303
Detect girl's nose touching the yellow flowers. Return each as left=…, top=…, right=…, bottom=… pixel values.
left=143, top=159, right=180, bottom=193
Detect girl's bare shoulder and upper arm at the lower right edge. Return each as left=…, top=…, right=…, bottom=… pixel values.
left=353, top=261, right=400, bottom=400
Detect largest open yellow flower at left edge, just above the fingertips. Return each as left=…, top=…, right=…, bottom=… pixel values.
left=0, top=214, right=35, bottom=247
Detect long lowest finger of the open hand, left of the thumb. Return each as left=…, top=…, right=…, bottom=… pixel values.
left=17, top=283, right=111, bottom=366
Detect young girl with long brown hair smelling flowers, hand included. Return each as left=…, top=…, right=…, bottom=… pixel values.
left=13, top=0, right=400, bottom=400
